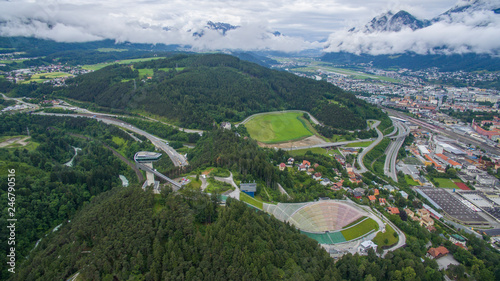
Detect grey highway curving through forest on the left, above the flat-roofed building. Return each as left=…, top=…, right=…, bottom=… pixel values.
left=34, top=112, right=189, bottom=167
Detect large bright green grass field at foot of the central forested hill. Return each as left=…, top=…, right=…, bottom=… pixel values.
left=245, top=112, right=313, bottom=143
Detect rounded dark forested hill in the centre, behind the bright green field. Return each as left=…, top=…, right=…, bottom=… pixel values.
left=54, top=54, right=384, bottom=130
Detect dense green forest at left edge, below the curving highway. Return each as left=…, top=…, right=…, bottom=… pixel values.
left=0, top=114, right=154, bottom=280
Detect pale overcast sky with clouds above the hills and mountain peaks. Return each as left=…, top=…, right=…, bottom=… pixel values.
left=0, top=0, right=498, bottom=51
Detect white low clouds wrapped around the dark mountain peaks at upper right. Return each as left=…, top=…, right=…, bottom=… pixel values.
left=325, top=1, right=500, bottom=55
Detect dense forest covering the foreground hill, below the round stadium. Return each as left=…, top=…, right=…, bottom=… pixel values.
left=11, top=184, right=448, bottom=280
